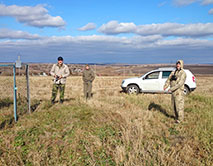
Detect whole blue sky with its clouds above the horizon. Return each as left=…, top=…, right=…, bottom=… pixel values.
left=0, top=0, right=213, bottom=64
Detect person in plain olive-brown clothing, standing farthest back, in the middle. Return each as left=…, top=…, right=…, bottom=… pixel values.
left=83, top=64, right=95, bottom=99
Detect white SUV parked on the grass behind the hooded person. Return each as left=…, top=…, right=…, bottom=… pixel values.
left=121, top=68, right=196, bottom=95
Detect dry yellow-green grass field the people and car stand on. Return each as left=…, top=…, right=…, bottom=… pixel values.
left=0, top=76, right=213, bottom=166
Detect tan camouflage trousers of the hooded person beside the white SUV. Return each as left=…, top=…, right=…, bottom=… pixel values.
left=172, top=91, right=184, bottom=121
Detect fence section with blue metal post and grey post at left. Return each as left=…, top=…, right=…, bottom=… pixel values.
left=0, top=64, right=30, bottom=124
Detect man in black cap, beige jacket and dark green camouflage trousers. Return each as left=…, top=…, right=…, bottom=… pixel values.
left=50, top=57, right=70, bottom=104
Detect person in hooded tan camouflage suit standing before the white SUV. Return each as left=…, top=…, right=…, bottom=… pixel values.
left=164, top=60, right=186, bottom=123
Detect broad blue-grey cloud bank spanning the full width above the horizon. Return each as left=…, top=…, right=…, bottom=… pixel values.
left=0, top=35, right=213, bottom=63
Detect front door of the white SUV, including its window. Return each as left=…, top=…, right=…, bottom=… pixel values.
left=141, top=71, right=160, bottom=92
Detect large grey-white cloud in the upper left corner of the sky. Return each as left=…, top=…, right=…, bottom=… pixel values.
left=0, top=4, right=66, bottom=28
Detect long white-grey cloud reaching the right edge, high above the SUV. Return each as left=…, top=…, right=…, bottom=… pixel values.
left=99, top=21, right=213, bottom=37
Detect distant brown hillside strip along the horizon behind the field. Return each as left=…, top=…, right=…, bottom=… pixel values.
left=0, top=63, right=213, bottom=76
